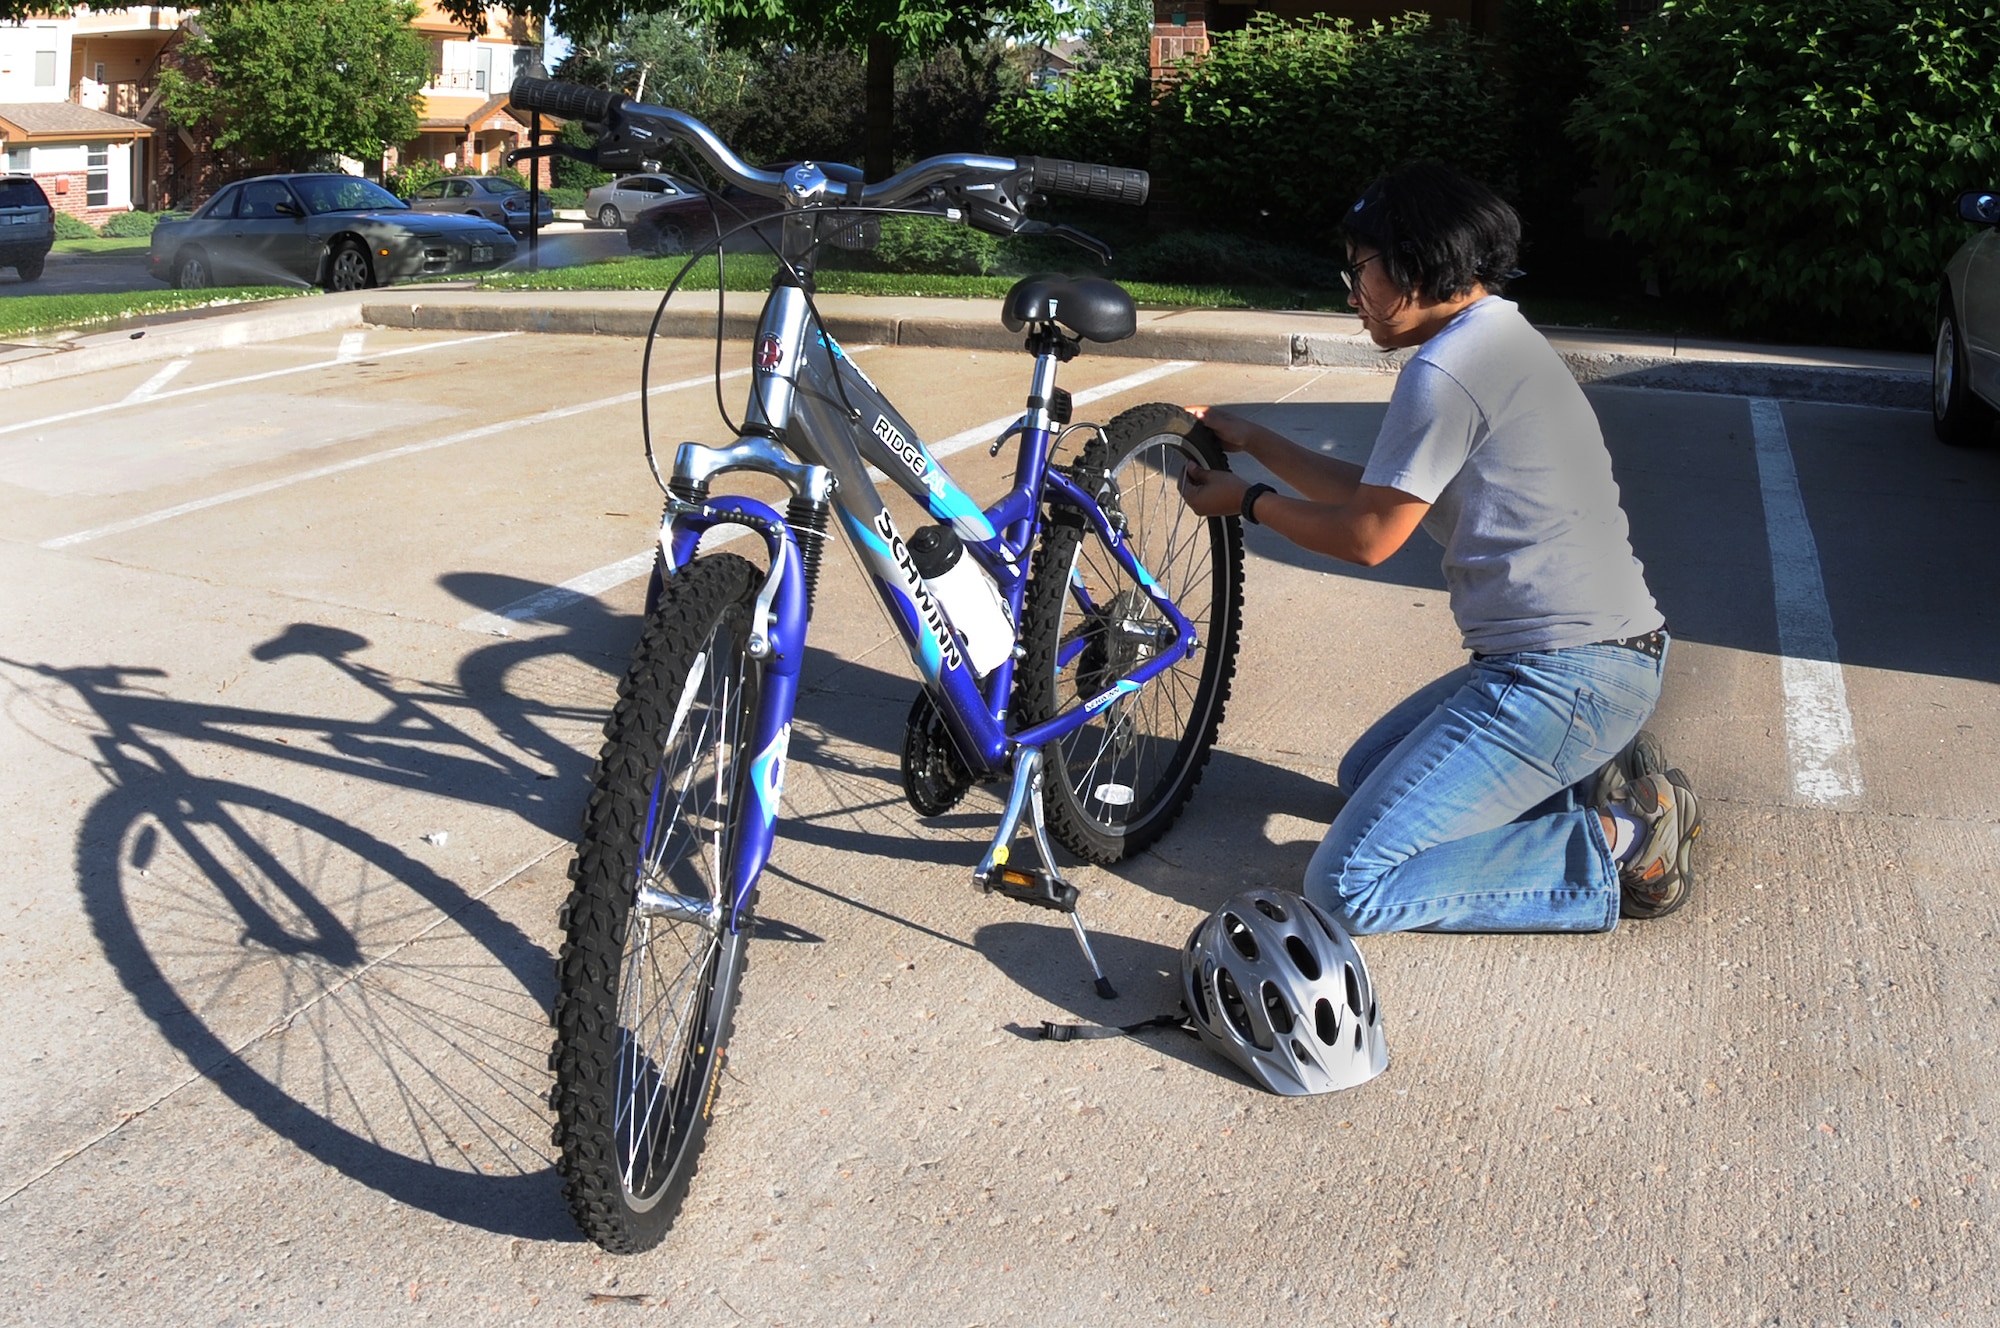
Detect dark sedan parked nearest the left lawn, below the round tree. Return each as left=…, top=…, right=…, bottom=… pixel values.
left=148, top=174, right=518, bottom=290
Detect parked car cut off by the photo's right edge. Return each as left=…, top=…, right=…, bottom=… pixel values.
left=1930, top=190, right=2000, bottom=446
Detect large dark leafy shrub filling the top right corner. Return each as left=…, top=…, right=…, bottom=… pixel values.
left=1572, top=0, right=2000, bottom=342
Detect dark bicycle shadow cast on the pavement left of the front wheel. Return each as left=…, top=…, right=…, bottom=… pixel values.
left=21, top=578, right=664, bottom=1240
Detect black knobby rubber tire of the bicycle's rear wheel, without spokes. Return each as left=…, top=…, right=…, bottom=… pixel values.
left=1016, top=402, right=1244, bottom=866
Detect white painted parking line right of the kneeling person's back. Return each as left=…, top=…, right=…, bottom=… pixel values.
left=1750, top=400, right=1862, bottom=804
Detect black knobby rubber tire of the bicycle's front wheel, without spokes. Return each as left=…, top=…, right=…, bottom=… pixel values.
left=550, top=554, right=762, bottom=1254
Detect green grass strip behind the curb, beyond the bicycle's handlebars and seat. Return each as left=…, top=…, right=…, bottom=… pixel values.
left=480, top=254, right=1338, bottom=308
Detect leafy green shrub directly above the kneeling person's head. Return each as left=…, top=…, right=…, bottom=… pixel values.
left=1154, top=14, right=1512, bottom=244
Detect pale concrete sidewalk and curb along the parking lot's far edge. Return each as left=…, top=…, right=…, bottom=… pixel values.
left=0, top=286, right=1930, bottom=410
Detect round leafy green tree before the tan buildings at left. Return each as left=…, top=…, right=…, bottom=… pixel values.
left=160, top=0, right=430, bottom=170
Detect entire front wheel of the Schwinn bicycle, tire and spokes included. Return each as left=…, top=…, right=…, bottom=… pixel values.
left=550, top=554, right=762, bottom=1254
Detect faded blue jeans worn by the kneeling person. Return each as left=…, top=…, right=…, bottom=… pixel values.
left=1304, top=646, right=1666, bottom=934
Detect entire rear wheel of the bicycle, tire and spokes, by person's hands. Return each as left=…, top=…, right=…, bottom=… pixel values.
left=1016, top=402, right=1244, bottom=864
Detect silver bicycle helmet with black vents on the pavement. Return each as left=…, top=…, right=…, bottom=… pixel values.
left=1180, top=890, right=1388, bottom=1098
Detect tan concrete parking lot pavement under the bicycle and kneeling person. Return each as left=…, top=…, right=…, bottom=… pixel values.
left=0, top=292, right=2000, bottom=1328
